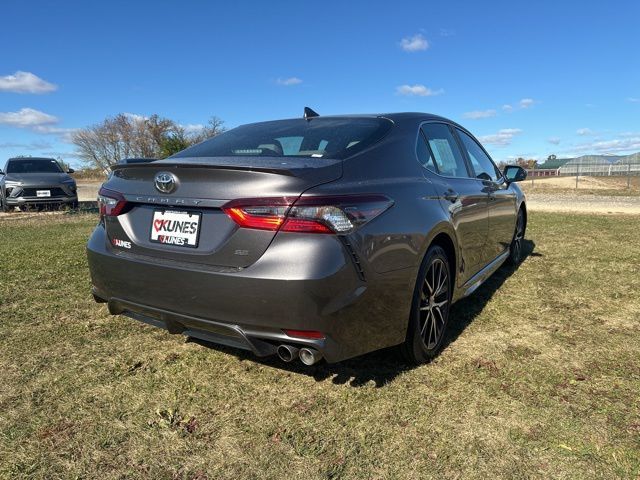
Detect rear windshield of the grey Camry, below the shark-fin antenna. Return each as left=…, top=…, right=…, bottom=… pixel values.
left=172, top=117, right=393, bottom=160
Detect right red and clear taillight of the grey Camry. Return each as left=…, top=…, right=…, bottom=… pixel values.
left=222, top=195, right=393, bottom=234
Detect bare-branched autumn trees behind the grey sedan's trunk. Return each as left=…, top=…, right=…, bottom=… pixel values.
left=71, top=113, right=225, bottom=171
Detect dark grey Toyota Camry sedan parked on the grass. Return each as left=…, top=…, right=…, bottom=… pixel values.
left=87, top=110, right=527, bottom=365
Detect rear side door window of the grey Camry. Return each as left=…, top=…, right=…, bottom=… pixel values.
left=422, top=123, right=469, bottom=178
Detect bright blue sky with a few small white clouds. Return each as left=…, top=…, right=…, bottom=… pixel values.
left=0, top=0, right=640, bottom=165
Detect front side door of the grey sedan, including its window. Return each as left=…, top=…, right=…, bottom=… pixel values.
left=456, top=129, right=517, bottom=263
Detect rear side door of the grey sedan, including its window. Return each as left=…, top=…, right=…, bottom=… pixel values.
left=418, top=122, right=489, bottom=284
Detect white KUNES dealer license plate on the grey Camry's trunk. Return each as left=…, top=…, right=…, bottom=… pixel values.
left=150, top=210, right=201, bottom=248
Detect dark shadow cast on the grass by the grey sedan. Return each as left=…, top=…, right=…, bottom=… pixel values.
left=189, top=240, right=542, bottom=388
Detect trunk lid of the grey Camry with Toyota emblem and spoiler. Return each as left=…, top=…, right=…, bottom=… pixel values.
left=103, top=157, right=342, bottom=269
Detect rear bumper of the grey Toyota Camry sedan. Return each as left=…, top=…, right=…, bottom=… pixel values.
left=87, top=225, right=413, bottom=362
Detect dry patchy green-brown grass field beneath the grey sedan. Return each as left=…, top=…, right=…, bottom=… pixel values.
left=0, top=213, right=640, bottom=480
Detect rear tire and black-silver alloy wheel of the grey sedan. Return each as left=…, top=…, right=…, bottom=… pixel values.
left=400, top=245, right=453, bottom=365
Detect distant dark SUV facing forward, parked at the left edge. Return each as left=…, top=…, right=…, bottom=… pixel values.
left=0, top=157, right=78, bottom=212
